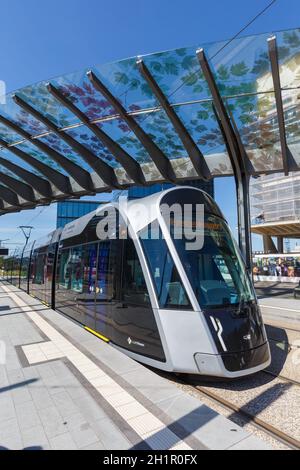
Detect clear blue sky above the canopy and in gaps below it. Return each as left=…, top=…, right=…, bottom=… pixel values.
left=0, top=0, right=300, bottom=249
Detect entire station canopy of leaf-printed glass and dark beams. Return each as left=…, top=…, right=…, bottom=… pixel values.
left=0, top=29, right=300, bottom=214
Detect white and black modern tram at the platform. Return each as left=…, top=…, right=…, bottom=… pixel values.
left=4, top=187, right=271, bottom=378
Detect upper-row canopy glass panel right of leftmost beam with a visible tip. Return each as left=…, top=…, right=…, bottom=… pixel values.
left=17, top=82, right=79, bottom=129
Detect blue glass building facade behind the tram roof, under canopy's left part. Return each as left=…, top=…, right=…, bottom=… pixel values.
left=56, top=201, right=101, bottom=228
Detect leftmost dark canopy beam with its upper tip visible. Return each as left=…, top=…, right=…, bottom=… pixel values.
left=13, top=95, right=119, bottom=190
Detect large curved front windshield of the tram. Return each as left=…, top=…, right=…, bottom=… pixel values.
left=170, top=214, right=255, bottom=308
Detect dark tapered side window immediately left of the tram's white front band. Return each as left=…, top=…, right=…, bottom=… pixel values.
left=122, top=238, right=150, bottom=304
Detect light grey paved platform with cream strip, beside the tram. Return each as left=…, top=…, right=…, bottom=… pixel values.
left=0, top=282, right=267, bottom=450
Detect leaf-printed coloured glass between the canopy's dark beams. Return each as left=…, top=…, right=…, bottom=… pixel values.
left=0, top=29, right=300, bottom=178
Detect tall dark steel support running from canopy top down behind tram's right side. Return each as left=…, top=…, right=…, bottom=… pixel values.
left=197, top=49, right=252, bottom=271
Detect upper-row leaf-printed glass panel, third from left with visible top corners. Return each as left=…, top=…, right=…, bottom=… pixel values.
left=51, top=69, right=116, bottom=121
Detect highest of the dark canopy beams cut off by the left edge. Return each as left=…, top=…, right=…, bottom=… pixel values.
left=0, top=115, right=93, bottom=191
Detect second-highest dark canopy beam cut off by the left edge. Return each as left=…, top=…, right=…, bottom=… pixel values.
left=0, top=139, right=72, bottom=195
